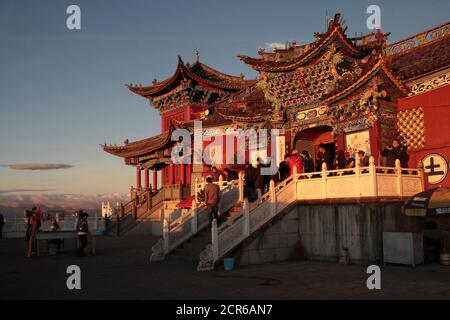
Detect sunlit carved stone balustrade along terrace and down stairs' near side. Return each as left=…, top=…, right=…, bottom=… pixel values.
left=197, top=157, right=424, bottom=271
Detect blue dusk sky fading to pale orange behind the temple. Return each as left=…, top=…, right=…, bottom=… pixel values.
left=0, top=0, right=450, bottom=209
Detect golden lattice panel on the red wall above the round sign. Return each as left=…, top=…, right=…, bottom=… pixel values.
left=397, top=107, right=425, bottom=148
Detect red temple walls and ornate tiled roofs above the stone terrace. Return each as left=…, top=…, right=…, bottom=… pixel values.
left=102, top=14, right=450, bottom=198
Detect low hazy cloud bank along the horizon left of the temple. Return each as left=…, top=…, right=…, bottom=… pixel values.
left=0, top=193, right=129, bottom=210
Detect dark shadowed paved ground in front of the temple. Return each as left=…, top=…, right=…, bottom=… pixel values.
left=0, top=236, right=450, bottom=299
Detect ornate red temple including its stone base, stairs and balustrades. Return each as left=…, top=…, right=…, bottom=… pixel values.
left=102, top=14, right=450, bottom=270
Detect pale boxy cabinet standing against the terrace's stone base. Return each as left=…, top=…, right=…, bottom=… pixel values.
left=383, top=232, right=424, bottom=267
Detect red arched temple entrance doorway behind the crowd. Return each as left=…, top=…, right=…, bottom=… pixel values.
left=294, top=126, right=336, bottom=171
